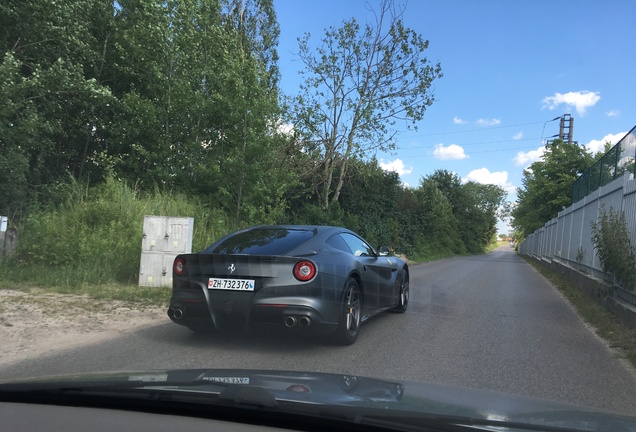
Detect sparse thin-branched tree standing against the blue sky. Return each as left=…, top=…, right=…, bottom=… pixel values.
left=292, top=1, right=442, bottom=208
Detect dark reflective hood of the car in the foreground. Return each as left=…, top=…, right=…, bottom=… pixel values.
left=0, top=369, right=636, bottom=431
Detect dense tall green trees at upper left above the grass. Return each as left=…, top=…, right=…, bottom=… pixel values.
left=0, top=0, right=284, bottom=223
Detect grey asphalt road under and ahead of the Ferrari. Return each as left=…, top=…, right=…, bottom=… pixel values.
left=0, top=247, right=636, bottom=415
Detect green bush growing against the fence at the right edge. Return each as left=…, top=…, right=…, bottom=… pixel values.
left=592, top=207, right=636, bottom=290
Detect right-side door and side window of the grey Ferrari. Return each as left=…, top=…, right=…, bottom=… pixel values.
left=341, top=233, right=396, bottom=309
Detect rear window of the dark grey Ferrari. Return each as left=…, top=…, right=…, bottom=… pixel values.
left=206, top=228, right=315, bottom=255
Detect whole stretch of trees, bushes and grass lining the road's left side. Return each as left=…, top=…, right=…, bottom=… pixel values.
left=0, top=0, right=506, bottom=298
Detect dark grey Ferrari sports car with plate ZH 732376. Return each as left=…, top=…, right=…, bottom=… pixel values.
left=168, top=225, right=409, bottom=345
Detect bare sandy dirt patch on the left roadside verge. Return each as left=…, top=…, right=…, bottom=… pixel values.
left=0, top=289, right=168, bottom=365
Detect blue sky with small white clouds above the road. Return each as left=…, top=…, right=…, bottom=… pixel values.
left=274, top=0, right=636, bottom=231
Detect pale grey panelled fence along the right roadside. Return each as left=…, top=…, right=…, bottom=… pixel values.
left=519, top=173, right=636, bottom=290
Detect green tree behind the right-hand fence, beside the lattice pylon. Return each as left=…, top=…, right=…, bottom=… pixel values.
left=512, top=140, right=594, bottom=237
